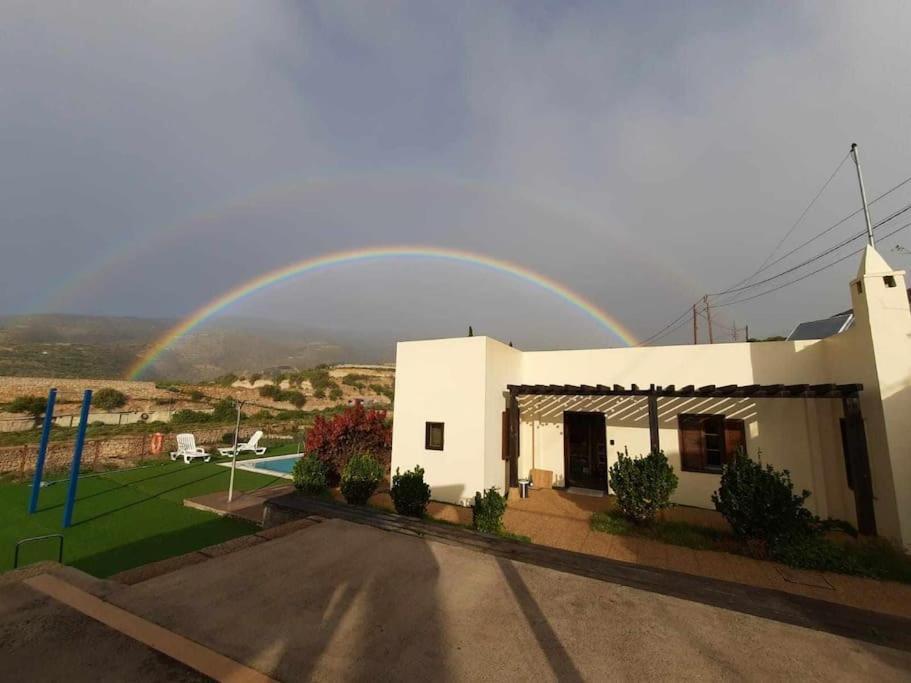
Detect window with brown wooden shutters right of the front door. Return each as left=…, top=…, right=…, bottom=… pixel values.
left=677, top=414, right=746, bottom=473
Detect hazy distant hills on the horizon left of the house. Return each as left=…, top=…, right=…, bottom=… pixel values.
left=0, top=314, right=392, bottom=380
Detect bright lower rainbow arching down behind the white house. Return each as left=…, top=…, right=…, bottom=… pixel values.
left=127, top=246, right=638, bottom=379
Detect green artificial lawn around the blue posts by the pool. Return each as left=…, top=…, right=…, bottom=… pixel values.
left=0, top=454, right=295, bottom=577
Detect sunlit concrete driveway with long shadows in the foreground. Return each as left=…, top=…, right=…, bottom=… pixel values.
left=108, top=520, right=911, bottom=681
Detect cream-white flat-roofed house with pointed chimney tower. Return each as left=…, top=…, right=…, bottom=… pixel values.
left=392, top=247, right=911, bottom=547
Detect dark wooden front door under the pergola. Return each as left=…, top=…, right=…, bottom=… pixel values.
left=563, top=411, right=607, bottom=491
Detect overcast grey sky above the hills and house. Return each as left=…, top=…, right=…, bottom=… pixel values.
left=0, top=0, right=911, bottom=349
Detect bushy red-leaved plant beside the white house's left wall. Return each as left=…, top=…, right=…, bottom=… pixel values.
left=307, top=404, right=392, bottom=485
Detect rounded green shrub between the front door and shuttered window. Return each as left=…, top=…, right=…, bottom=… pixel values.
left=608, top=451, right=677, bottom=524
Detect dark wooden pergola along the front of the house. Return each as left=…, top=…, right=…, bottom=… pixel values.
left=506, top=384, right=876, bottom=534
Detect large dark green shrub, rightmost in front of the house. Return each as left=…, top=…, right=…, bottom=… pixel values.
left=712, top=452, right=814, bottom=545
